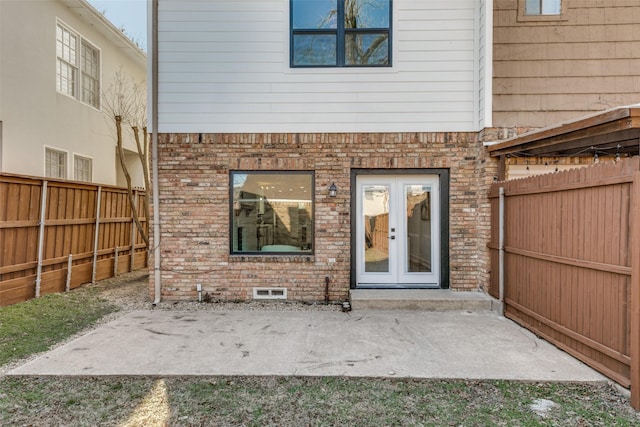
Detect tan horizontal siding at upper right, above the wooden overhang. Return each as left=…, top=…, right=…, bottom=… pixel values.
left=493, top=0, right=640, bottom=127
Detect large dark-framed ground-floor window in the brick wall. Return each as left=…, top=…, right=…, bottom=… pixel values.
left=230, top=171, right=313, bottom=255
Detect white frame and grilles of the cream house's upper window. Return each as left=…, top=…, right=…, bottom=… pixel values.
left=56, top=19, right=102, bottom=110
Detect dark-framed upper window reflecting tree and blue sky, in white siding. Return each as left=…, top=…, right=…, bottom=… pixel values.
left=290, top=0, right=392, bottom=67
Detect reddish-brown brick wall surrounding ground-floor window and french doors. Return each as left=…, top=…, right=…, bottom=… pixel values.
left=152, top=133, right=495, bottom=301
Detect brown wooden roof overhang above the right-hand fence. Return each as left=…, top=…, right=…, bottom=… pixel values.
left=487, top=104, right=640, bottom=157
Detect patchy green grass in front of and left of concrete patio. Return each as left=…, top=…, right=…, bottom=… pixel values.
left=0, top=280, right=640, bottom=426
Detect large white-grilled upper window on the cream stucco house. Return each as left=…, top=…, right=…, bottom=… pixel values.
left=56, top=22, right=100, bottom=108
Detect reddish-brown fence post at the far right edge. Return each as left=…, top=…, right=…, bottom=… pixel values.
left=629, top=172, right=640, bottom=410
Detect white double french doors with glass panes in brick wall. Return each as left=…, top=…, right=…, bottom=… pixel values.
left=355, top=175, right=440, bottom=287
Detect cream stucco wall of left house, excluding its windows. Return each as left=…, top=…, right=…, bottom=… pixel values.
left=0, top=0, right=146, bottom=186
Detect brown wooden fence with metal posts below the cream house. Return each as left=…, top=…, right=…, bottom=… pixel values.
left=0, top=174, right=147, bottom=306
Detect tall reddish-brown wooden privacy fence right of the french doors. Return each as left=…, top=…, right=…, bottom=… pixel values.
left=489, top=157, right=640, bottom=408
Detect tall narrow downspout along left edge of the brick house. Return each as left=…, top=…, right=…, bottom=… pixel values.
left=151, top=0, right=162, bottom=304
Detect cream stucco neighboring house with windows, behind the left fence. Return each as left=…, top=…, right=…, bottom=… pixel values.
left=0, top=0, right=146, bottom=186
